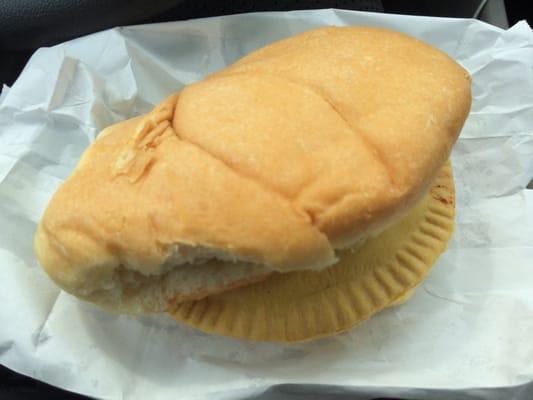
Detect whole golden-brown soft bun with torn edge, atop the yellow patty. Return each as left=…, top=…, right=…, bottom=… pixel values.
left=35, top=28, right=470, bottom=311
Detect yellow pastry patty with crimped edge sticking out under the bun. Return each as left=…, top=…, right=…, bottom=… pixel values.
left=171, top=162, right=455, bottom=342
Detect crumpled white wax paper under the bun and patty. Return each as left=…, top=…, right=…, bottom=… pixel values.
left=0, top=10, right=533, bottom=399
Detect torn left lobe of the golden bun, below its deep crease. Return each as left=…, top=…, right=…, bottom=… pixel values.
left=35, top=96, right=328, bottom=313
